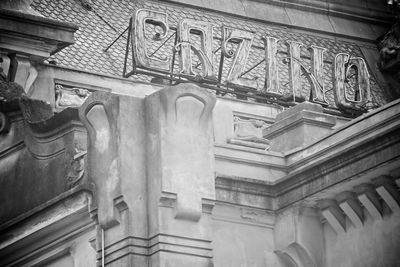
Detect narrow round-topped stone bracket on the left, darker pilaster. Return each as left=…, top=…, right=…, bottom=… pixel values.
left=79, top=92, right=122, bottom=229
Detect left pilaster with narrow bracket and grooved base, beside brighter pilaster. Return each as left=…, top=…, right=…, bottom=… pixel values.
left=80, top=92, right=148, bottom=266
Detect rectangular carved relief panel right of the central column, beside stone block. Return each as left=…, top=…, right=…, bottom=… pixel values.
left=229, top=116, right=270, bottom=150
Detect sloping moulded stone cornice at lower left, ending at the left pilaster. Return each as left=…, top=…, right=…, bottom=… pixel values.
left=0, top=189, right=94, bottom=266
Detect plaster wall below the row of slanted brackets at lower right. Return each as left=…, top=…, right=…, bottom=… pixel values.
left=324, top=212, right=400, bottom=267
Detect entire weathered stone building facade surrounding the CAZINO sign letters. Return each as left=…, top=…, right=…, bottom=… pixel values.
left=0, top=0, right=400, bottom=267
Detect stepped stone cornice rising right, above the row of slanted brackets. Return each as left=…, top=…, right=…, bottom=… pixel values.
left=216, top=100, right=400, bottom=210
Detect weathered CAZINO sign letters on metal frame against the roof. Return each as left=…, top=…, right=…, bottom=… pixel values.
left=123, top=9, right=373, bottom=114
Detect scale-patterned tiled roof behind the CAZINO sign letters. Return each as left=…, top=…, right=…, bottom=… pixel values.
left=32, top=0, right=387, bottom=109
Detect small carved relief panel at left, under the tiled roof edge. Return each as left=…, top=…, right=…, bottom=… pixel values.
left=55, top=84, right=91, bottom=108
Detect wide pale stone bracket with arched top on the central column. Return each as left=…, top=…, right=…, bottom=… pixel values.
left=146, top=84, right=215, bottom=224
